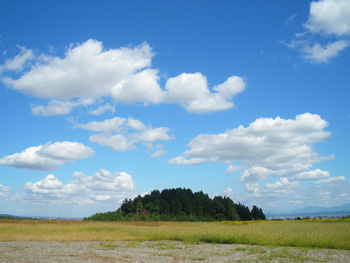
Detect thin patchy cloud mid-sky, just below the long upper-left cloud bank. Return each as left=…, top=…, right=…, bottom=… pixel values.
left=74, top=117, right=174, bottom=155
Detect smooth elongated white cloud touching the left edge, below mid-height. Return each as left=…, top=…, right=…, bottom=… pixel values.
left=0, top=141, right=94, bottom=171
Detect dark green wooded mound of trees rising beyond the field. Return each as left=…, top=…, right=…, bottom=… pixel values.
left=84, top=188, right=266, bottom=222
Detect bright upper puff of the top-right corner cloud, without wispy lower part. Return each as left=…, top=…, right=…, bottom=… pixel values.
left=304, top=0, right=350, bottom=36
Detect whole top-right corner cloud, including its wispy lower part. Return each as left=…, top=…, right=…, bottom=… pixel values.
left=287, top=0, right=350, bottom=64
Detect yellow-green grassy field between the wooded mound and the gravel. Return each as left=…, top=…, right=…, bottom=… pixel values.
left=0, top=220, right=350, bottom=250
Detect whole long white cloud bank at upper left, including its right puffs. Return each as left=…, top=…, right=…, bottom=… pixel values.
left=0, top=39, right=245, bottom=115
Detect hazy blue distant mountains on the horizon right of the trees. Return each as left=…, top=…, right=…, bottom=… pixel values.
left=266, top=203, right=350, bottom=217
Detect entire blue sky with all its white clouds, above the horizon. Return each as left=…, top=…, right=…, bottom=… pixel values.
left=0, top=0, right=350, bottom=217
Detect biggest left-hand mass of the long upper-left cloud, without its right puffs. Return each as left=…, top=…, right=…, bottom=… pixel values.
left=1, top=39, right=153, bottom=100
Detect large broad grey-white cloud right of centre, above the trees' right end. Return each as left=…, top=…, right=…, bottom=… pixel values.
left=169, top=113, right=334, bottom=183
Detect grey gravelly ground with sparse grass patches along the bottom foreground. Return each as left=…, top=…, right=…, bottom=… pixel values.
left=0, top=241, right=350, bottom=263
